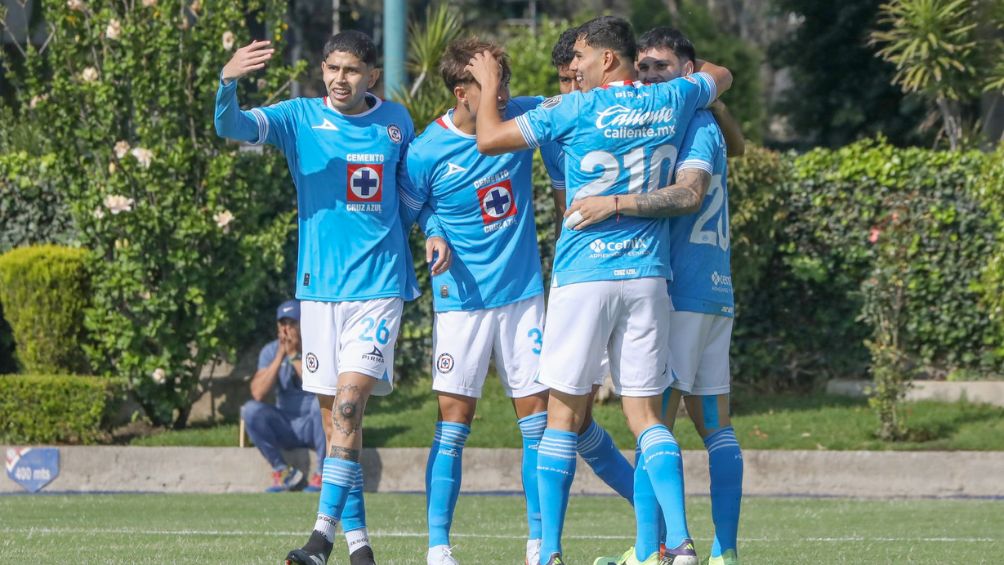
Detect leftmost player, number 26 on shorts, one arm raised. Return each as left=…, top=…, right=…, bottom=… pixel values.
left=215, top=31, right=447, bottom=565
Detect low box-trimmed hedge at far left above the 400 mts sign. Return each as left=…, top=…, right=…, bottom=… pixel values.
left=0, top=374, right=120, bottom=445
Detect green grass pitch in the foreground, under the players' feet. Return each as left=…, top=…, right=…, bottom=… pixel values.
left=0, top=493, right=1004, bottom=565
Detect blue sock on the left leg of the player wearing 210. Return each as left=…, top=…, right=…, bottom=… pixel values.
left=537, top=428, right=578, bottom=563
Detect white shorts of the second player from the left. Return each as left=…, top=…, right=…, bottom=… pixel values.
left=433, top=295, right=547, bottom=398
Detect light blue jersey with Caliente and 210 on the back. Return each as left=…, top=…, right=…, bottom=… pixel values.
left=516, top=73, right=715, bottom=286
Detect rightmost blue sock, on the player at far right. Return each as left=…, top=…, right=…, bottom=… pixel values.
left=704, top=426, right=743, bottom=557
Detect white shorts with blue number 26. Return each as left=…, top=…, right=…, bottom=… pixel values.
left=300, top=298, right=405, bottom=396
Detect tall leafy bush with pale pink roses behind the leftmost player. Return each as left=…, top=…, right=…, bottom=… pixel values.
left=1, top=0, right=297, bottom=426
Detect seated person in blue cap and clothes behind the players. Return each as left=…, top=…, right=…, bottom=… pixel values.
left=241, top=300, right=327, bottom=493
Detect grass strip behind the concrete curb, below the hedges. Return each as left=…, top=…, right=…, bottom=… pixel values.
left=133, top=378, right=1004, bottom=451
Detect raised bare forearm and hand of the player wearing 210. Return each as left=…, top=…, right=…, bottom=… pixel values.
left=467, top=51, right=529, bottom=155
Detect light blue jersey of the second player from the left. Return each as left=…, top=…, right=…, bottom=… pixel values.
left=402, top=97, right=543, bottom=312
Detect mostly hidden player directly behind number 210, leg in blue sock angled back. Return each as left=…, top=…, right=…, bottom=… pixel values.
left=540, top=27, right=635, bottom=503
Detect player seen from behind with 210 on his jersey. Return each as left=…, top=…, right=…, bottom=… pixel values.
left=470, top=16, right=732, bottom=565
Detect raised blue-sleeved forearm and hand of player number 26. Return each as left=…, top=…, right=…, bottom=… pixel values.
left=214, top=40, right=275, bottom=143
